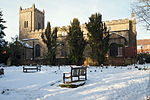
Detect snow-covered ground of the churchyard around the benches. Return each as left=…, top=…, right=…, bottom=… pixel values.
left=0, top=64, right=150, bottom=100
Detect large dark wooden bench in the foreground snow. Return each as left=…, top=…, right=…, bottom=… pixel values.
left=63, top=66, right=87, bottom=83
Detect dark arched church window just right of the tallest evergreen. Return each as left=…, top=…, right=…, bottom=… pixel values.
left=110, top=43, right=118, bottom=57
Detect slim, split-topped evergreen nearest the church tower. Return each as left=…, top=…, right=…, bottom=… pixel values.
left=41, top=22, right=57, bottom=65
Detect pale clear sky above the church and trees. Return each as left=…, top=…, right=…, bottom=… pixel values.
left=0, top=0, right=150, bottom=41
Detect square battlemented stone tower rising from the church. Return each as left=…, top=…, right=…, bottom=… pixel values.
left=19, top=4, right=45, bottom=40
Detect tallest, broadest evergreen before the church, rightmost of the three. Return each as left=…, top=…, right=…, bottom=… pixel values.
left=86, top=13, right=109, bottom=65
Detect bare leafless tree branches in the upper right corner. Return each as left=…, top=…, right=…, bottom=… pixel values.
left=133, top=0, right=150, bottom=31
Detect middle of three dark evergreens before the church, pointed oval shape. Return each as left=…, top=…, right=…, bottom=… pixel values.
left=67, top=18, right=86, bottom=65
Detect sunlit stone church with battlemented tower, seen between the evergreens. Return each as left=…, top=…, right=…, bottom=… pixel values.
left=19, top=4, right=137, bottom=65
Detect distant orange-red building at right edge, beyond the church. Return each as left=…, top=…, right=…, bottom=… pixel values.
left=137, top=39, right=150, bottom=53
